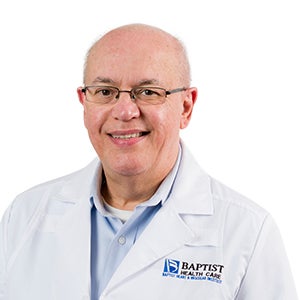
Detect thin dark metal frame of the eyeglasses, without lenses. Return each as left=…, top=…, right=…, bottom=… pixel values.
left=81, top=85, right=187, bottom=104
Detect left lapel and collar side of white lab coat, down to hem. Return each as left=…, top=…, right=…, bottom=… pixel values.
left=46, top=162, right=98, bottom=299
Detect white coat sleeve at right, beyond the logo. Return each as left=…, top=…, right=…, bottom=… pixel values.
left=236, top=216, right=298, bottom=300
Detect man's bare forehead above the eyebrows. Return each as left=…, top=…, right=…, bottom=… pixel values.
left=85, top=30, right=179, bottom=82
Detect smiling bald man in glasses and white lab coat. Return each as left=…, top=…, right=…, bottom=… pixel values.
left=0, top=24, right=297, bottom=300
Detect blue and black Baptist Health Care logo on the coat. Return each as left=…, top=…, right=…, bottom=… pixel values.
left=162, top=258, right=224, bottom=283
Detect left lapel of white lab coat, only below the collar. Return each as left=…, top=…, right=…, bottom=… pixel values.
left=55, top=193, right=90, bottom=299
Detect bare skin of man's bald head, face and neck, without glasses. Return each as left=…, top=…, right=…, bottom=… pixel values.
left=77, top=24, right=197, bottom=210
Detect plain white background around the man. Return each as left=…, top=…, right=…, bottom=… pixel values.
left=0, top=0, right=300, bottom=292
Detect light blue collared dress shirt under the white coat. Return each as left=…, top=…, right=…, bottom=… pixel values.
left=90, top=150, right=181, bottom=300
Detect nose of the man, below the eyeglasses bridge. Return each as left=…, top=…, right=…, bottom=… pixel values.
left=112, top=91, right=140, bottom=122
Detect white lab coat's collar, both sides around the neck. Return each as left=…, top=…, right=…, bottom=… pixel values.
left=56, top=141, right=213, bottom=215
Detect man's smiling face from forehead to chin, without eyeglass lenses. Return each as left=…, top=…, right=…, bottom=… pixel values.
left=78, top=28, right=196, bottom=178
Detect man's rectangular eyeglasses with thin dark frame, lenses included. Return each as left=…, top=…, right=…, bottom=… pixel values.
left=81, top=86, right=186, bottom=104
